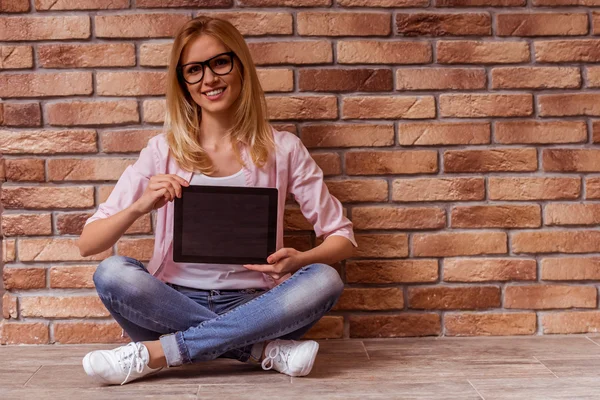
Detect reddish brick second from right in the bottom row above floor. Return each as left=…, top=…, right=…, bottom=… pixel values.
left=444, top=313, right=537, bottom=336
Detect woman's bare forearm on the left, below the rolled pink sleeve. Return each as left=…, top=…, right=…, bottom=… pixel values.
left=77, top=206, right=143, bottom=257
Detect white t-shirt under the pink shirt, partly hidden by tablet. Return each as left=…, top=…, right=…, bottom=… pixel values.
left=163, top=169, right=269, bottom=290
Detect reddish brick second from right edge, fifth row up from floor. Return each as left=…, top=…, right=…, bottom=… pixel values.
left=451, top=204, right=542, bottom=229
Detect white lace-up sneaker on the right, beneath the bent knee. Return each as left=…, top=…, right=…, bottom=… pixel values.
left=262, top=340, right=319, bottom=376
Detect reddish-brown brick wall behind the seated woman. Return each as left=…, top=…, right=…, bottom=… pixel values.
left=0, top=0, right=600, bottom=343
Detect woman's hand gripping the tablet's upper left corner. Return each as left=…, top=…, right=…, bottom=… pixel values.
left=134, top=174, right=190, bottom=214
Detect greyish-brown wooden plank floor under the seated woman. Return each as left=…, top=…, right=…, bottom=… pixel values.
left=0, top=335, right=600, bottom=400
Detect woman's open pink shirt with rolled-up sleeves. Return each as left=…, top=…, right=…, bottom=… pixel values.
left=85, top=129, right=357, bottom=287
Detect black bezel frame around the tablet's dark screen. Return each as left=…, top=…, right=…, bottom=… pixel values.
left=173, top=185, right=278, bottom=265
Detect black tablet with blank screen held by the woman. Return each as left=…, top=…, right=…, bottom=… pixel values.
left=173, top=185, right=277, bottom=264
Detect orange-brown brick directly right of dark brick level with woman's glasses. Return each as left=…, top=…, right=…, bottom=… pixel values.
left=396, top=68, right=487, bottom=90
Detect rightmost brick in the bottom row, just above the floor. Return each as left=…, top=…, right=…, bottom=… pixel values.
left=541, top=311, right=600, bottom=334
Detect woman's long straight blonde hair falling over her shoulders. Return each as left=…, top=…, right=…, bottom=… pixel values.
left=165, top=16, right=275, bottom=175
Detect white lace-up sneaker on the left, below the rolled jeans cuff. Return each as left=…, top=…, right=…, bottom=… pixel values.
left=83, top=342, right=162, bottom=385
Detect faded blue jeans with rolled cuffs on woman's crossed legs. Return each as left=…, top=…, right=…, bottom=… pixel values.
left=94, top=256, right=344, bottom=367
